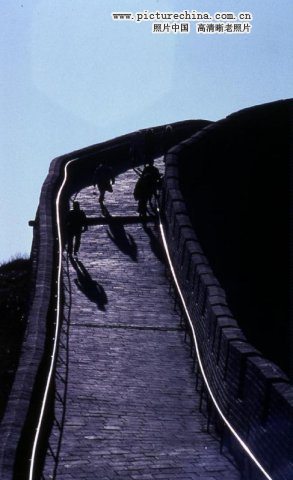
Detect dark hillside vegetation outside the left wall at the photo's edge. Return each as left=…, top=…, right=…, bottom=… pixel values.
left=0, top=255, right=30, bottom=419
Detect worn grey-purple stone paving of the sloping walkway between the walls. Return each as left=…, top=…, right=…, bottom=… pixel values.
left=43, top=160, right=240, bottom=480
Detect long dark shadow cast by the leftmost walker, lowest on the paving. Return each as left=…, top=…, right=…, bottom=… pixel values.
left=71, top=258, right=108, bottom=311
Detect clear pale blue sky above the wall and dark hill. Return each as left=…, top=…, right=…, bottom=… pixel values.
left=0, top=0, right=293, bottom=261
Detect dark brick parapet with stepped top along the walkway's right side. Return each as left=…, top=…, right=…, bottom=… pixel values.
left=162, top=120, right=293, bottom=480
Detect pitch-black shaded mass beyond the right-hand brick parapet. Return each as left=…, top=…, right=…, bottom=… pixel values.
left=179, top=101, right=292, bottom=373
